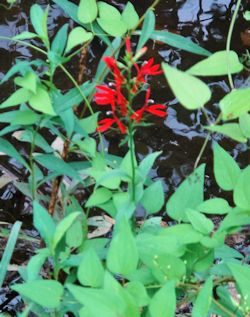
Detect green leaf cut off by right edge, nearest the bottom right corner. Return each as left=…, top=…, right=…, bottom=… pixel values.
left=227, top=263, right=250, bottom=307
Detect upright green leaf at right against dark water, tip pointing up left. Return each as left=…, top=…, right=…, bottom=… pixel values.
left=214, top=143, right=241, bottom=190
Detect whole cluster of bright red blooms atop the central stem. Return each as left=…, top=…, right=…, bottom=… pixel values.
left=95, top=39, right=167, bottom=134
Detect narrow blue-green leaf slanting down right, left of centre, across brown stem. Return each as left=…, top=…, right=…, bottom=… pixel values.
left=35, top=154, right=81, bottom=181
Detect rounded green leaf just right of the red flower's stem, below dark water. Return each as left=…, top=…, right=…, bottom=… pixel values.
left=141, top=180, right=164, bottom=214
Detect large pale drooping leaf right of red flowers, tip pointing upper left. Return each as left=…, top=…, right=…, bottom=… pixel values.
left=162, top=63, right=211, bottom=110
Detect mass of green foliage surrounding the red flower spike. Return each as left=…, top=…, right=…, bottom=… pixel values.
left=0, top=0, right=250, bottom=317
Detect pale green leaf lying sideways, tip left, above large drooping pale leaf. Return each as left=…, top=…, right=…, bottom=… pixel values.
left=187, top=51, right=243, bottom=76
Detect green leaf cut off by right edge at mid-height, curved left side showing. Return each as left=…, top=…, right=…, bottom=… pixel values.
left=234, top=166, right=250, bottom=210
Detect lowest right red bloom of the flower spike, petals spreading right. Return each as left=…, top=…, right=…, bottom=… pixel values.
left=130, top=88, right=167, bottom=123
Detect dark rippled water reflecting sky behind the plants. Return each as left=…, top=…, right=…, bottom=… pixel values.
left=0, top=0, right=249, bottom=311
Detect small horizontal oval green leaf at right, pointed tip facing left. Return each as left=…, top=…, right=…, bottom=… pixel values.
left=195, top=198, right=232, bottom=215
